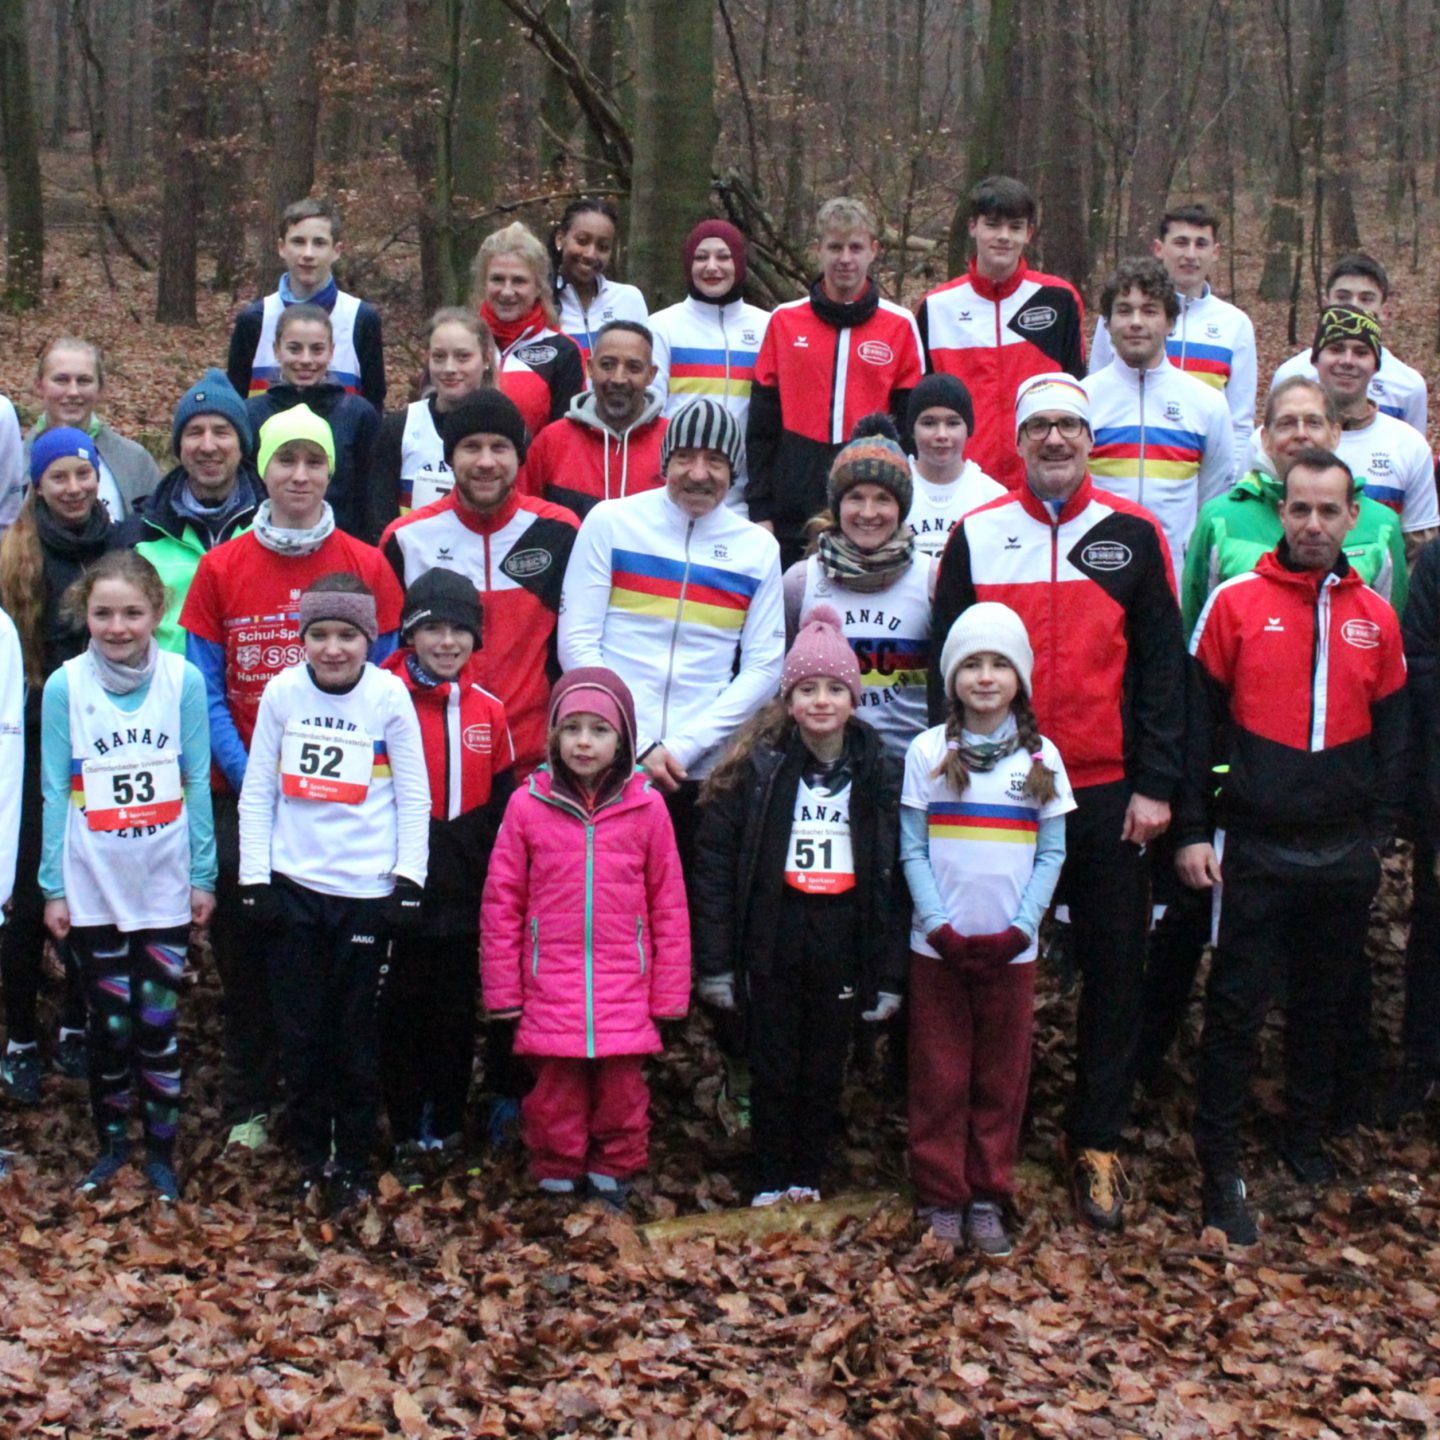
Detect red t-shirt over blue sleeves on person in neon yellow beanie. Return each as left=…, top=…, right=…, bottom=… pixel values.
left=180, top=530, right=403, bottom=750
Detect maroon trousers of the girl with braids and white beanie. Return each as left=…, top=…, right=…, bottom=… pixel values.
left=909, top=952, right=1035, bottom=1208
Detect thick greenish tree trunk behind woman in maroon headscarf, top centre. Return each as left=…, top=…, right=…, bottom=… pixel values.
left=631, top=0, right=719, bottom=310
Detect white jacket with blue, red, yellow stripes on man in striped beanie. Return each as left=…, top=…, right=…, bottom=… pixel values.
left=559, top=490, right=785, bottom=779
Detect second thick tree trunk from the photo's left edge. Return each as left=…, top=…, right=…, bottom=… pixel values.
left=156, top=0, right=215, bottom=325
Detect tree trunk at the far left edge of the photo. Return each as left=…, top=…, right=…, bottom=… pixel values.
left=0, top=0, right=45, bottom=310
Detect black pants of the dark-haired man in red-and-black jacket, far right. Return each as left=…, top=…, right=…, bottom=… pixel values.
left=1195, top=834, right=1380, bottom=1174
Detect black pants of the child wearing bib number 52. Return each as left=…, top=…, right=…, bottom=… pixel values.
left=269, top=877, right=387, bottom=1171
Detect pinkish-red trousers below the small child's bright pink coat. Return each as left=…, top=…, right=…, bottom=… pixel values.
left=520, top=1056, right=649, bottom=1179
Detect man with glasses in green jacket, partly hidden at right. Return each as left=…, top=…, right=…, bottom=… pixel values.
left=1179, top=376, right=1410, bottom=635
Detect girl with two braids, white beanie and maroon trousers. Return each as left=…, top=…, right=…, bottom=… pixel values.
left=900, top=600, right=1076, bottom=1256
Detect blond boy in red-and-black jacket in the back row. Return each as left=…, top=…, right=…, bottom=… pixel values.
left=744, top=196, right=924, bottom=567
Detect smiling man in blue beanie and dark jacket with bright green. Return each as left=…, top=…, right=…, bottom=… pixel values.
left=122, top=369, right=265, bottom=655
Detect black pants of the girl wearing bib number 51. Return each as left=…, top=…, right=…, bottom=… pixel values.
left=749, top=894, right=857, bottom=1189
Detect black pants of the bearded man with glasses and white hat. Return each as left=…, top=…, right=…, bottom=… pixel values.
left=1058, top=782, right=1151, bottom=1151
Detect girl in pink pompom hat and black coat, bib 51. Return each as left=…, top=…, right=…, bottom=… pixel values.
left=690, top=605, right=904, bottom=1205
